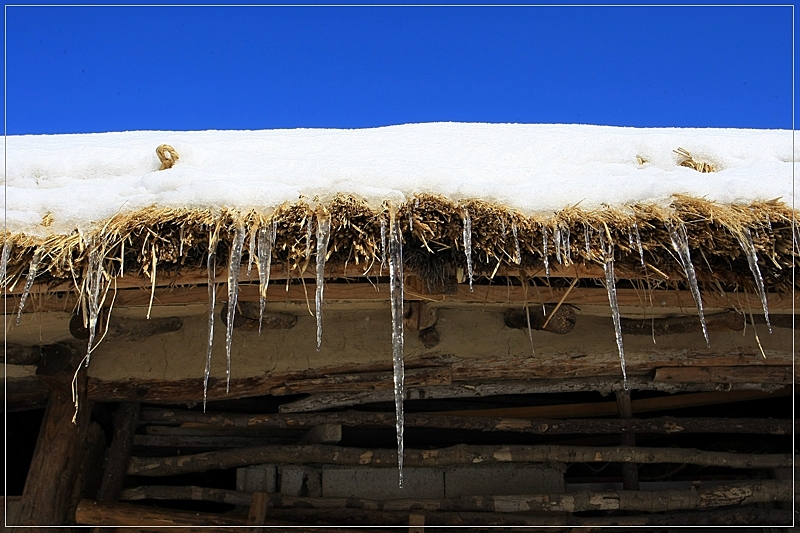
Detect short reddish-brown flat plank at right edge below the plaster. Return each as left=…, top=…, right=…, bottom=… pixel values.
left=653, top=365, right=793, bottom=384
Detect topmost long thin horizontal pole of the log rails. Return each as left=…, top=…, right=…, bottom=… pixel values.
left=142, top=409, right=800, bottom=435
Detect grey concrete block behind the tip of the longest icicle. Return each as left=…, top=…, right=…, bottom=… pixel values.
left=322, top=467, right=444, bottom=500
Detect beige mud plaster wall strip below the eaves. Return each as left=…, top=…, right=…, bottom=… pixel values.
left=78, top=306, right=792, bottom=380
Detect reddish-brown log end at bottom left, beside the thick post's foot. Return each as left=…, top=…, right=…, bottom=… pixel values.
left=75, top=500, right=247, bottom=526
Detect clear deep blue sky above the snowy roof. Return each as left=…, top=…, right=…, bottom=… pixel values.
left=6, top=6, right=793, bottom=134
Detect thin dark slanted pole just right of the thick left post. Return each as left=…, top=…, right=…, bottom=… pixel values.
left=97, top=402, right=140, bottom=502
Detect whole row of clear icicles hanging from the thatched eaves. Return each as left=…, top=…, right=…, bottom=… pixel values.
left=0, top=208, right=780, bottom=487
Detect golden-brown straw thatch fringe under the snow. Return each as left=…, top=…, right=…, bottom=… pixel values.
left=4, top=195, right=797, bottom=302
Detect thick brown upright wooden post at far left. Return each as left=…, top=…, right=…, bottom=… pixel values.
left=17, top=356, right=92, bottom=526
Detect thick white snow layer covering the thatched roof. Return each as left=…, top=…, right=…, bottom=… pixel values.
left=4, top=123, right=793, bottom=235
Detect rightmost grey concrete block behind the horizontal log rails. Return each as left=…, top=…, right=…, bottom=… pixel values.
left=444, top=464, right=564, bottom=498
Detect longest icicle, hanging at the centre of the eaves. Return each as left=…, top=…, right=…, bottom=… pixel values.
left=389, top=210, right=406, bottom=488
